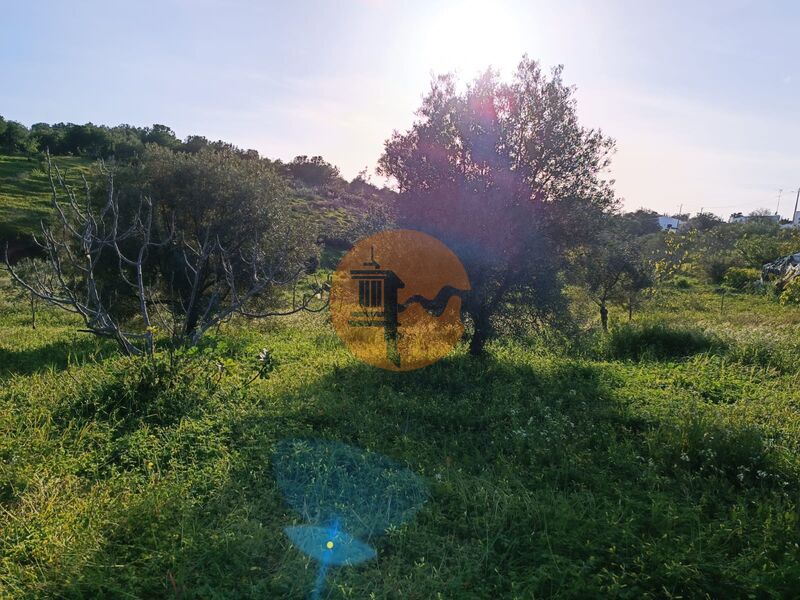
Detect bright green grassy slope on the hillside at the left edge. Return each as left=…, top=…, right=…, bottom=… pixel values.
left=0, top=155, right=91, bottom=246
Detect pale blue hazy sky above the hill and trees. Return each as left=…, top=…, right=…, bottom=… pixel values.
left=0, top=0, right=800, bottom=217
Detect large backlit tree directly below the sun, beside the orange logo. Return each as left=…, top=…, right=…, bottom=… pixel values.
left=379, top=57, right=614, bottom=354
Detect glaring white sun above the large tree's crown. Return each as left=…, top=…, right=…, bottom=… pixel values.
left=421, top=1, right=525, bottom=78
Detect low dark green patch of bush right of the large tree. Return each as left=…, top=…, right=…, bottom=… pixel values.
left=605, top=323, right=722, bottom=359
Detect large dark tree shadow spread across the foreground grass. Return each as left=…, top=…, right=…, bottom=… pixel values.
left=47, top=356, right=790, bottom=599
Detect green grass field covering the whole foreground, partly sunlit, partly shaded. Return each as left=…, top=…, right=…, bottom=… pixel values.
left=0, top=266, right=800, bottom=599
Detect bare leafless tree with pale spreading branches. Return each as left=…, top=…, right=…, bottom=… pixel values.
left=5, top=156, right=329, bottom=355
